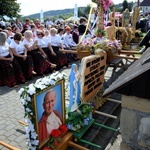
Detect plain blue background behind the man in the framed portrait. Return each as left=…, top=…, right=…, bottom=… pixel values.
left=36, top=84, right=63, bottom=122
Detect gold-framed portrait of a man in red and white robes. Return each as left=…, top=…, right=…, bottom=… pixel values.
left=33, top=79, right=65, bottom=149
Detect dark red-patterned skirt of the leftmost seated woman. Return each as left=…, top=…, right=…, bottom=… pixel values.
left=0, top=55, right=25, bottom=87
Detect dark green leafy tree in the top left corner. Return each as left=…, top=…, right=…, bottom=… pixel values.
left=0, top=0, right=20, bottom=18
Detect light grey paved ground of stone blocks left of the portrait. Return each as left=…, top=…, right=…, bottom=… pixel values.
left=0, top=59, right=129, bottom=150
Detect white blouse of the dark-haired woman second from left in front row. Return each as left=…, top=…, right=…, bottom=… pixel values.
left=10, top=40, right=25, bottom=54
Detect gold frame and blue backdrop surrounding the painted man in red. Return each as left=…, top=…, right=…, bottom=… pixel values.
left=33, top=79, right=65, bottom=149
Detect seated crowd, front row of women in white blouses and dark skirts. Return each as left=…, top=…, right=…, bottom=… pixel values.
left=0, top=18, right=92, bottom=87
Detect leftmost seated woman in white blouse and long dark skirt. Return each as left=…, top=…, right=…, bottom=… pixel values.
left=0, top=32, right=25, bottom=87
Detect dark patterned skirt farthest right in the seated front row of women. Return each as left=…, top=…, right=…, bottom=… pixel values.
left=50, top=46, right=68, bottom=69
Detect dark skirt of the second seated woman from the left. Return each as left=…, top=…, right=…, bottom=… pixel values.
left=15, top=54, right=34, bottom=79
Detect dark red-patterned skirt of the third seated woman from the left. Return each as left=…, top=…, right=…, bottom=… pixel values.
left=28, top=49, right=51, bottom=75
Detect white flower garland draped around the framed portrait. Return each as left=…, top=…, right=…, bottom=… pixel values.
left=18, top=72, right=68, bottom=150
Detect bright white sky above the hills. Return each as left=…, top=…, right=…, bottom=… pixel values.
left=17, top=0, right=131, bottom=16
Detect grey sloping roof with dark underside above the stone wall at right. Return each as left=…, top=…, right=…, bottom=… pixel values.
left=103, top=48, right=150, bottom=99
